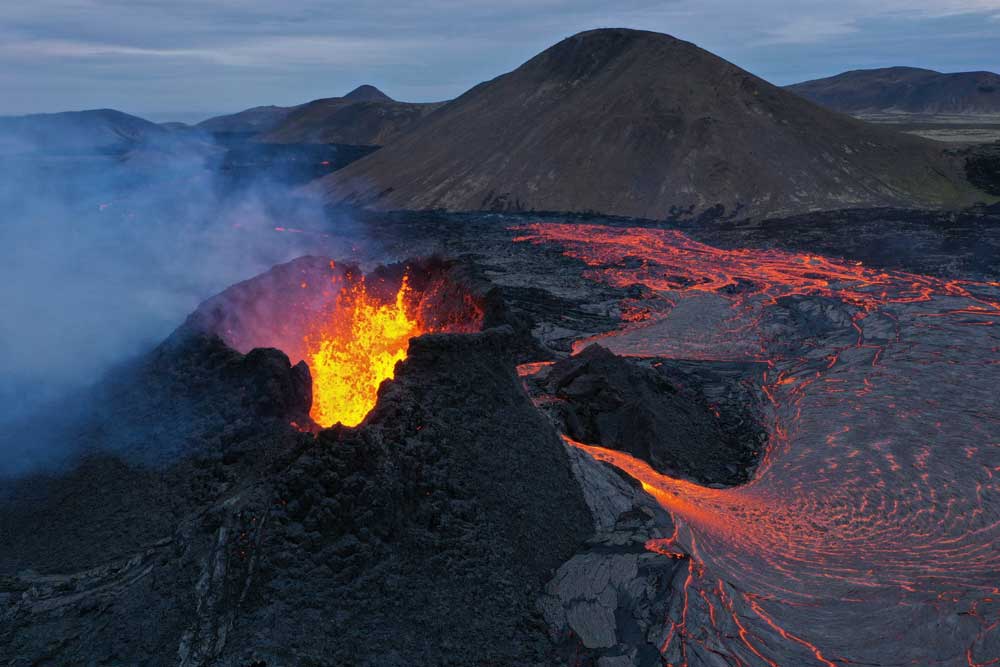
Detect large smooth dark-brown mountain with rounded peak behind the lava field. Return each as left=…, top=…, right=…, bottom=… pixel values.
left=311, top=29, right=975, bottom=219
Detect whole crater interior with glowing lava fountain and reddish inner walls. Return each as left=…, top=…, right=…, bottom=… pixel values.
left=187, top=257, right=483, bottom=427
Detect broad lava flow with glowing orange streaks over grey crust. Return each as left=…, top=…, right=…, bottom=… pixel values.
left=517, top=223, right=1000, bottom=667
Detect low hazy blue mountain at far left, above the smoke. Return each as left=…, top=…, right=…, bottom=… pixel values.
left=0, top=109, right=170, bottom=153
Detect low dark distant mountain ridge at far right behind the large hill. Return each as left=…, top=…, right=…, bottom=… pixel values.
left=787, top=67, right=1000, bottom=114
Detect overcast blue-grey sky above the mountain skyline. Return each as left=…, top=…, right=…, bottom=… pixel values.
left=0, top=0, right=1000, bottom=120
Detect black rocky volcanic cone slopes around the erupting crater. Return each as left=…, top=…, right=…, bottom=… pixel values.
left=0, top=268, right=594, bottom=667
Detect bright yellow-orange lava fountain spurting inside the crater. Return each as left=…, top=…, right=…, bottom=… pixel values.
left=306, top=277, right=424, bottom=427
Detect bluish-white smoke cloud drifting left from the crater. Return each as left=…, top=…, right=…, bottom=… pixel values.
left=0, top=122, right=368, bottom=472
